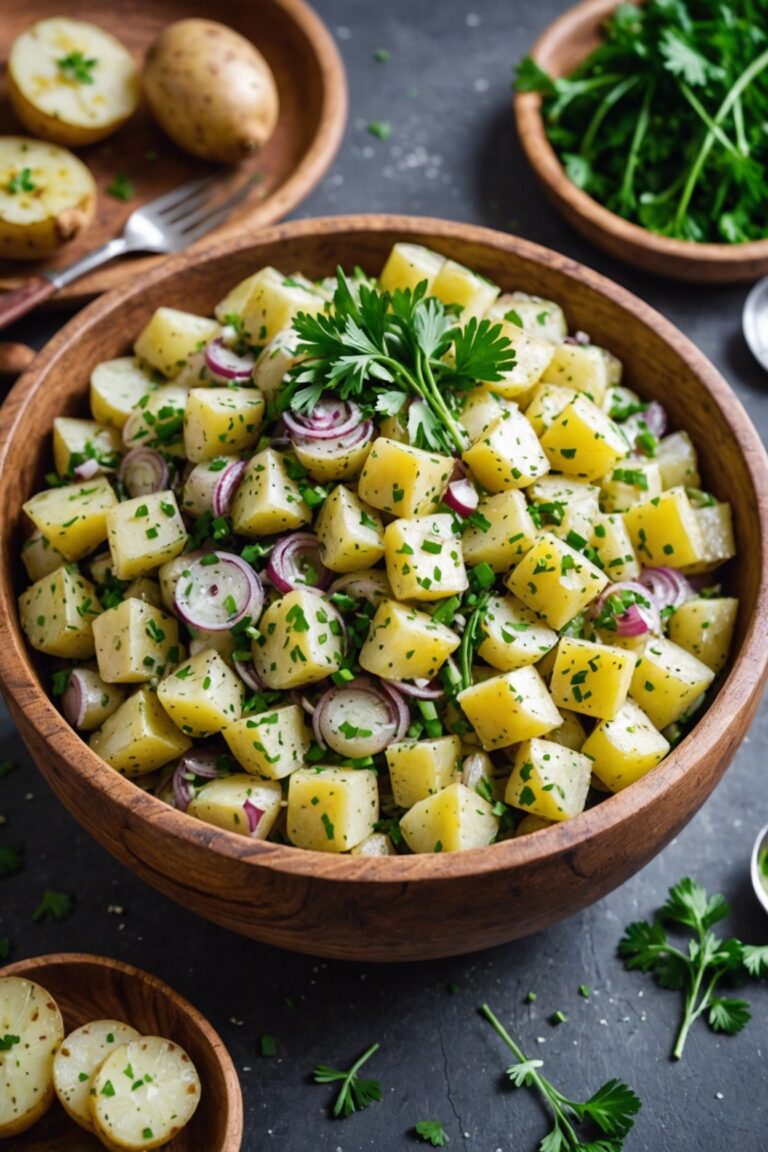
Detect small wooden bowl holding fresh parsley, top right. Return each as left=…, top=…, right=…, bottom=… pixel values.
left=515, top=0, right=768, bottom=283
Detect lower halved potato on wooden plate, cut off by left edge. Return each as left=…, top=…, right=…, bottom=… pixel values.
left=0, top=136, right=96, bottom=260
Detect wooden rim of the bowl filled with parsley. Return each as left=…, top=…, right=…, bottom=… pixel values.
left=514, top=0, right=768, bottom=268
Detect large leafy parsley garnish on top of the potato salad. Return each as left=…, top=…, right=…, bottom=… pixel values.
left=286, top=268, right=515, bottom=454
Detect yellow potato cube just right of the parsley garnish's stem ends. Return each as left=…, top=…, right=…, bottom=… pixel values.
left=463, top=408, right=549, bottom=492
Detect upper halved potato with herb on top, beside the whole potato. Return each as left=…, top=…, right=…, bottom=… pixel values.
left=8, top=16, right=140, bottom=147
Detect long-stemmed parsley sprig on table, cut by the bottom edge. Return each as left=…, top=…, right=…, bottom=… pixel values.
left=480, top=1005, right=640, bottom=1152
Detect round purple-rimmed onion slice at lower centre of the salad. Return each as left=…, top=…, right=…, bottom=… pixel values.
left=312, top=676, right=410, bottom=759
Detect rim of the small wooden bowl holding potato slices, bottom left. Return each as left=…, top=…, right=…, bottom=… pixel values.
left=0, top=952, right=243, bottom=1152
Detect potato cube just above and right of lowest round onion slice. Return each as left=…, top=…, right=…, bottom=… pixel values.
left=359, top=599, right=461, bottom=680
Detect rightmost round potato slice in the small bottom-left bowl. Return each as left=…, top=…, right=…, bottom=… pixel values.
left=90, top=1036, right=200, bottom=1152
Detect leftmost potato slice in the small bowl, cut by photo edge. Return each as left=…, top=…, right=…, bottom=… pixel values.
left=0, top=976, right=64, bottom=1138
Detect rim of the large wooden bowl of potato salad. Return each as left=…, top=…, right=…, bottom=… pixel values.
left=0, top=213, right=768, bottom=885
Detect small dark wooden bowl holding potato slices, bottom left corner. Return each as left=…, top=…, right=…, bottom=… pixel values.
left=0, top=952, right=243, bottom=1152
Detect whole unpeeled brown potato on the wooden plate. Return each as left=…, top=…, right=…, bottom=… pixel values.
left=144, top=20, right=280, bottom=164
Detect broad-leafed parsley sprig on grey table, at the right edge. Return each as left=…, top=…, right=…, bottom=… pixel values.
left=618, top=877, right=768, bottom=1060
